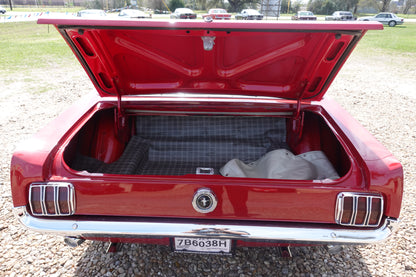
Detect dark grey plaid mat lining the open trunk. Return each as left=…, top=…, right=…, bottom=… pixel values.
left=70, top=116, right=288, bottom=175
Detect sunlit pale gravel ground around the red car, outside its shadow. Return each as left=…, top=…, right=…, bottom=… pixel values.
left=0, top=47, right=416, bottom=276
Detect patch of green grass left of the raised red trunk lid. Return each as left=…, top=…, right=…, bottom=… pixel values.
left=0, top=22, right=74, bottom=72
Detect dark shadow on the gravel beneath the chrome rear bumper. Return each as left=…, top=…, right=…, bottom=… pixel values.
left=76, top=242, right=371, bottom=276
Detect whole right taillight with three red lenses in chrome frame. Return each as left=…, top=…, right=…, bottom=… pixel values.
left=335, top=192, right=383, bottom=227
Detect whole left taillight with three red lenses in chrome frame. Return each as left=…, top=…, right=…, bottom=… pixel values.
left=29, top=182, right=75, bottom=216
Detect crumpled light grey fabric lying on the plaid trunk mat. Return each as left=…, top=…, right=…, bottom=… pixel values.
left=220, top=149, right=339, bottom=180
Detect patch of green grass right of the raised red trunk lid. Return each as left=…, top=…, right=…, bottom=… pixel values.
left=357, top=22, right=416, bottom=54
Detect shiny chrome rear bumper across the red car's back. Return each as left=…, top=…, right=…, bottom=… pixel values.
left=14, top=207, right=397, bottom=244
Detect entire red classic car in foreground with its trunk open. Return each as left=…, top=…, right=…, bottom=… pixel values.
left=11, top=18, right=403, bottom=252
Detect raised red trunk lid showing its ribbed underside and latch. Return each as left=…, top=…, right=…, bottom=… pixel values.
left=38, top=18, right=383, bottom=100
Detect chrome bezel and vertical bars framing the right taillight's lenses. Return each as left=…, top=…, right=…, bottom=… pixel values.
left=335, top=192, right=384, bottom=227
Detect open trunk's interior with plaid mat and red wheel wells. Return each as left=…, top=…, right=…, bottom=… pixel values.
left=64, top=105, right=350, bottom=180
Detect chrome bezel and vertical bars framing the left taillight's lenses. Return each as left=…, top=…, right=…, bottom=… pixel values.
left=29, top=182, right=75, bottom=216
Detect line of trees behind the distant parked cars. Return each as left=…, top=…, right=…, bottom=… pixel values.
left=14, top=0, right=416, bottom=14
